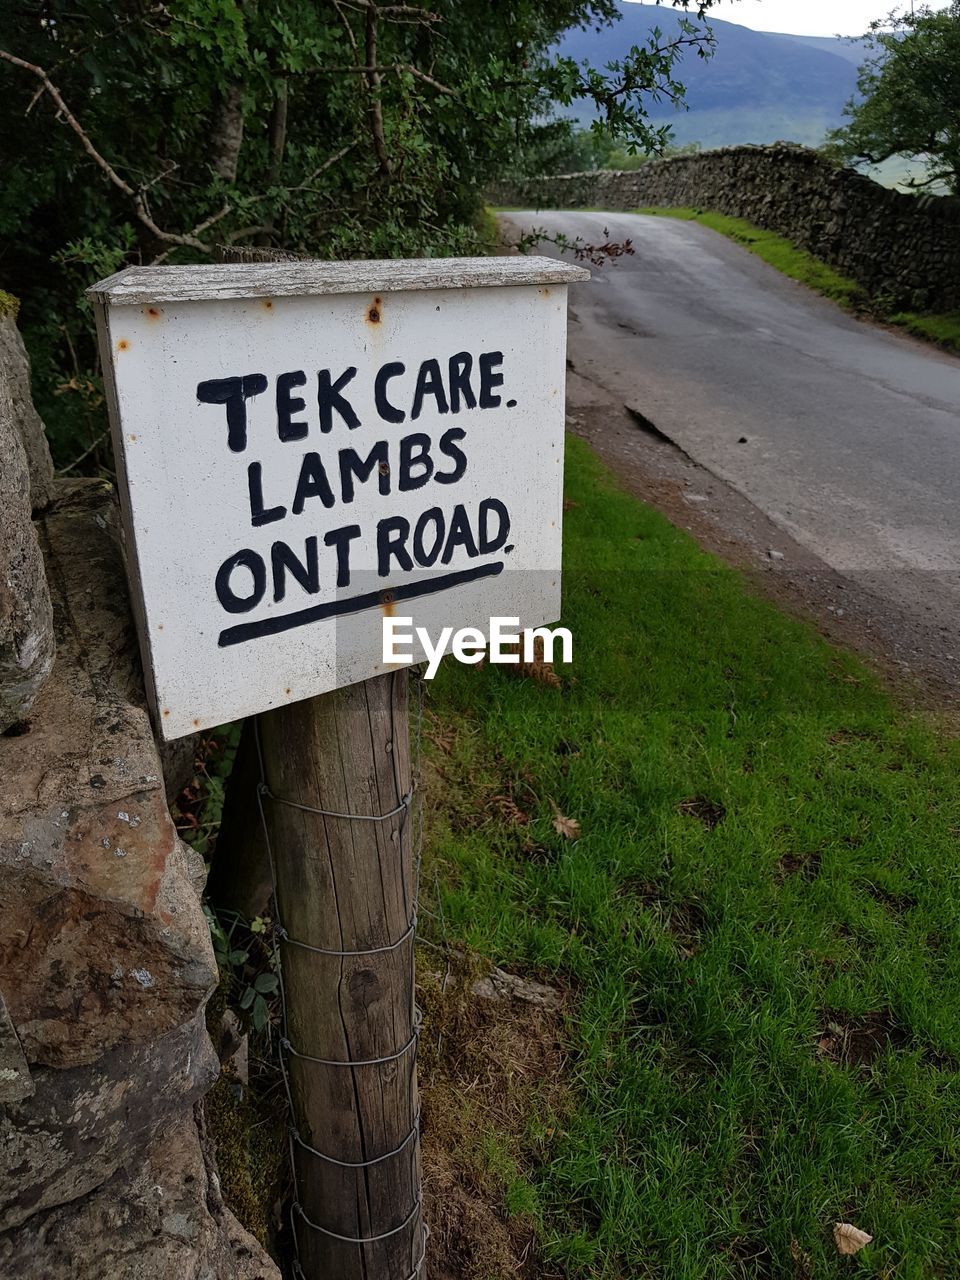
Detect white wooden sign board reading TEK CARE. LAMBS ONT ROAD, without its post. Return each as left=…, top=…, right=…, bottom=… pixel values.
left=90, top=257, right=588, bottom=739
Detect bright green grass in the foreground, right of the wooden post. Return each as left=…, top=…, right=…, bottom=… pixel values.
left=429, top=439, right=960, bottom=1280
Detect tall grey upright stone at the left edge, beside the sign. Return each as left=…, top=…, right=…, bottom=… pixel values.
left=0, top=302, right=54, bottom=733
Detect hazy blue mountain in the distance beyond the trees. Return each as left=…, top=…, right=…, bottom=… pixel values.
left=558, top=4, right=863, bottom=147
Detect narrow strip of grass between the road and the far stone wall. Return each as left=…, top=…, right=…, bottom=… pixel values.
left=634, top=207, right=960, bottom=351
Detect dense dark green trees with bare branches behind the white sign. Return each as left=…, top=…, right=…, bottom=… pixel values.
left=0, top=0, right=713, bottom=465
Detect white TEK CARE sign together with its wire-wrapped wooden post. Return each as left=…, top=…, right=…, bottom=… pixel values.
left=88, top=252, right=589, bottom=1280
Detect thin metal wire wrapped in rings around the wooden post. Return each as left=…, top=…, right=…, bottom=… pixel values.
left=253, top=673, right=429, bottom=1280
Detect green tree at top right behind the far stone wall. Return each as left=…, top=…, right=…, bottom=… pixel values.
left=831, top=0, right=960, bottom=193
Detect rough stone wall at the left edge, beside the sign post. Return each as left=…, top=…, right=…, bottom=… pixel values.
left=0, top=296, right=279, bottom=1280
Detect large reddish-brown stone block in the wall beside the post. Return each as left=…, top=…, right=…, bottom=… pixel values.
left=0, top=481, right=216, bottom=1068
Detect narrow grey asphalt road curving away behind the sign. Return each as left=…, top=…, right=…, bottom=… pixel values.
left=522, top=212, right=960, bottom=645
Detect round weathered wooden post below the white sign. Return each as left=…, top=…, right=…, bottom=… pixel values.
left=260, top=669, right=426, bottom=1280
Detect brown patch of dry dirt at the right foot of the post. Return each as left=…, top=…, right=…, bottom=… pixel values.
left=419, top=952, right=568, bottom=1280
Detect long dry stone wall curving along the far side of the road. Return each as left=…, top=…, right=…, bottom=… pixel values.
left=490, top=143, right=960, bottom=311
